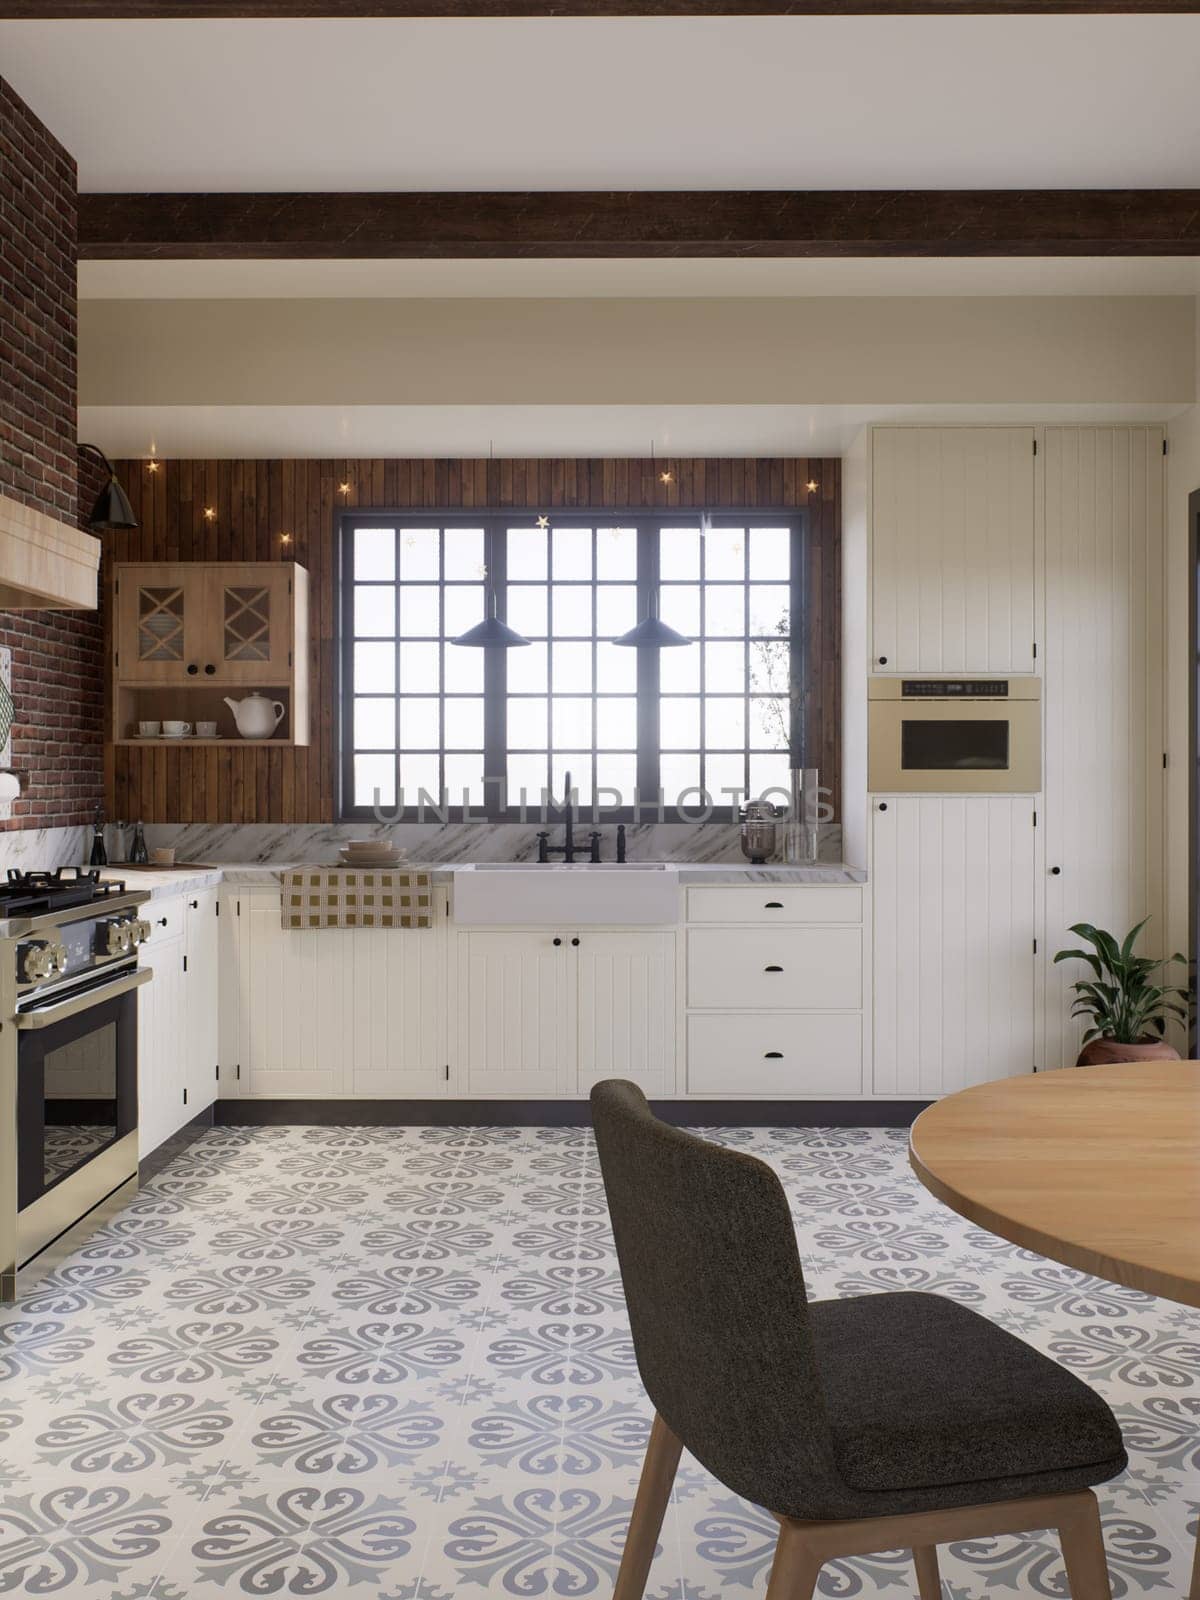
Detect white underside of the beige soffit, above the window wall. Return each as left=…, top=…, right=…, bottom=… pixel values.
left=78, top=405, right=1182, bottom=459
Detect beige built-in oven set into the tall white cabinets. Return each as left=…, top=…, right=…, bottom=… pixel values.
left=867, top=677, right=1042, bottom=794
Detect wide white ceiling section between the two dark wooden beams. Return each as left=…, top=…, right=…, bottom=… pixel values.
left=0, top=16, right=1200, bottom=190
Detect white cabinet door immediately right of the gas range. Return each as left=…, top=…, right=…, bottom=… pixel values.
left=138, top=901, right=190, bottom=1158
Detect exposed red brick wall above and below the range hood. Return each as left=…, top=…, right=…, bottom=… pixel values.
left=0, top=78, right=104, bottom=829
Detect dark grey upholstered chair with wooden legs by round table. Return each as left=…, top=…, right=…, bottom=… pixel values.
left=592, top=1080, right=1125, bottom=1600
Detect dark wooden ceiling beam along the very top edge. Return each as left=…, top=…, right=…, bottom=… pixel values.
left=9, top=0, right=1200, bottom=11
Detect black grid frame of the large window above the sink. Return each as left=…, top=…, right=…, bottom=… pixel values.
left=334, top=506, right=810, bottom=822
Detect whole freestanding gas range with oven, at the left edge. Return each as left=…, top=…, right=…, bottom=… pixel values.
left=0, top=875, right=152, bottom=1299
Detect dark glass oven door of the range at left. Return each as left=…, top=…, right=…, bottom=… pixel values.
left=16, top=989, right=138, bottom=1210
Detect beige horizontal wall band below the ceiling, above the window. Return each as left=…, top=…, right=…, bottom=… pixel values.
left=80, top=296, right=1197, bottom=410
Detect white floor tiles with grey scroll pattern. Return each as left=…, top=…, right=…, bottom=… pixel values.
left=0, top=1126, right=1200, bottom=1600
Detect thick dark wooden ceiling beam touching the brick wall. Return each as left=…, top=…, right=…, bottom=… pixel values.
left=80, top=189, right=1200, bottom=261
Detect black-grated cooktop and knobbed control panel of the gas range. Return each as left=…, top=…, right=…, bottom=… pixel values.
left=0, top=867, right=150, bottom=1000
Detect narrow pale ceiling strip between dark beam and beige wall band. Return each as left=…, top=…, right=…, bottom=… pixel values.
left=78, top=256, right=1200, bottom=299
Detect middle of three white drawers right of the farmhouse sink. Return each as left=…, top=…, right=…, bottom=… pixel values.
left=688, top=926, right=862, bottom=1011
